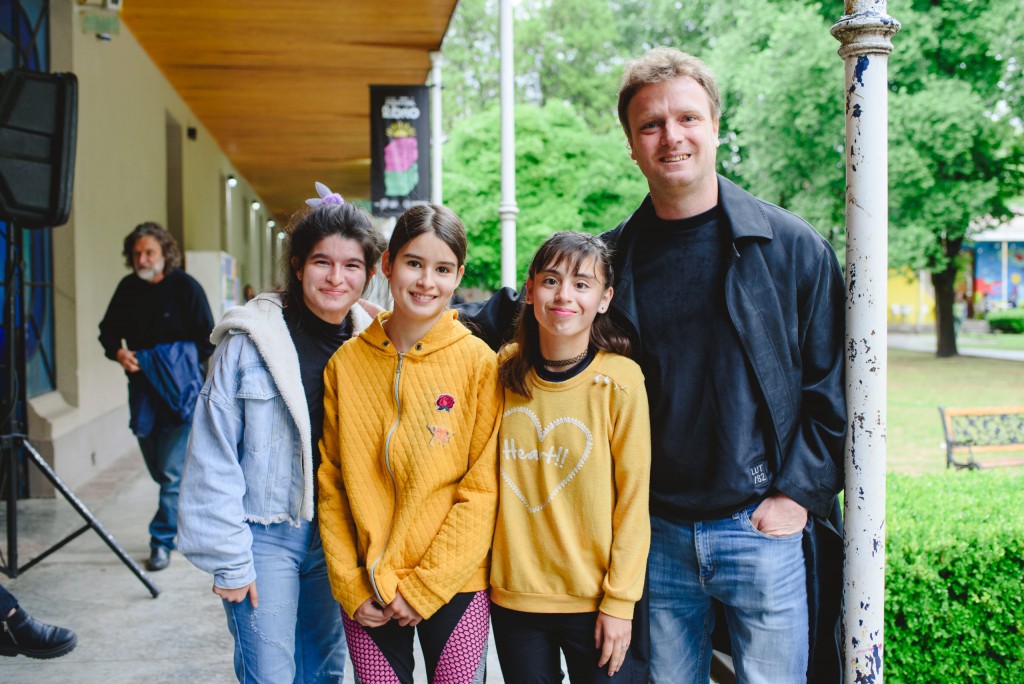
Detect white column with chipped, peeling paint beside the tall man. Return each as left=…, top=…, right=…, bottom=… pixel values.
left=831, top=0, right=900, bottom=684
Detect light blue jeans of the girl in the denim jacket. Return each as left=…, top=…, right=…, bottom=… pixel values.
left=223, top=521, right=348, bottom=684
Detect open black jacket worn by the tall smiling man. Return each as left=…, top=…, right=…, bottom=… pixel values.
left=601, top=176, right=847, bottom=518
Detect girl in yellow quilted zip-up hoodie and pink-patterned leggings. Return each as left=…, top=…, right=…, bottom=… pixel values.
left=311, top=206, right=502, bottom=682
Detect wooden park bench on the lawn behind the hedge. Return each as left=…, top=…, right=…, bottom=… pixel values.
left=939, top=407, right=1024, bottom=470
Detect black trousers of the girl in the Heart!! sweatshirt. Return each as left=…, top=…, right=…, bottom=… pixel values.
left=490, top=604, right=633, bottom=684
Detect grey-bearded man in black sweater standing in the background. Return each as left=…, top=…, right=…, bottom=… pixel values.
left=99, top=222, right=213, bottom=570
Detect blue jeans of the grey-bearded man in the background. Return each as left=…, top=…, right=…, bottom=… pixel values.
left=138, top=424, right=190, bottom=550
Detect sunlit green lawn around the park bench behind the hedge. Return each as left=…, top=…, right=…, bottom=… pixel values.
left=887, top=350, right=1024, bottom=474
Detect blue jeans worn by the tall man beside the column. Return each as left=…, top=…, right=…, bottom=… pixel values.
left=647, top=506, right=809, bottom=684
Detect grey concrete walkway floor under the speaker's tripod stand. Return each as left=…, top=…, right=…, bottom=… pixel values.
left=0, top=455, right=503, bottom=684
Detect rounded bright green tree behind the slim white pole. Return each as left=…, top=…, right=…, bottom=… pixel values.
left=444, top=102, right=646, bottom=289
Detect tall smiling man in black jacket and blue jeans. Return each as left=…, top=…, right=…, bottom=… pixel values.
left=472, top=48, right=847, bottom=684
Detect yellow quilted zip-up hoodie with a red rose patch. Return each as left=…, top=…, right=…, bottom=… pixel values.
left=317, top=311, right=502, bottom=618
